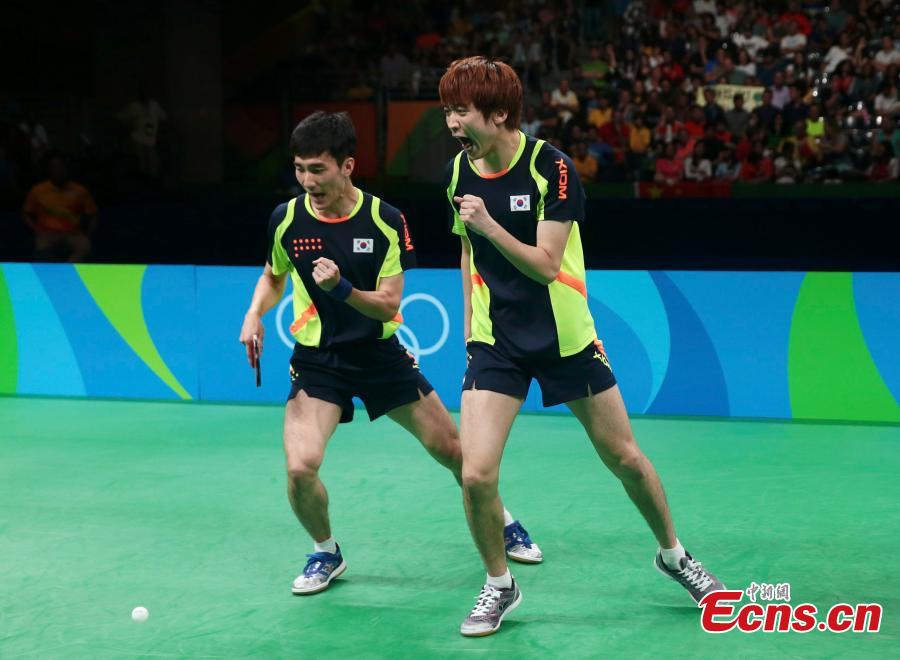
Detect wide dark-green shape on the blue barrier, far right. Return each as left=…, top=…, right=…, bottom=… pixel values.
left=788, top=273, right=900, bottom=422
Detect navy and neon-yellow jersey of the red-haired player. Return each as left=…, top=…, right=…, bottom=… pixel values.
left=446, top=133, right=597, bottom=358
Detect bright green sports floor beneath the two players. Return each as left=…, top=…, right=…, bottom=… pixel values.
left=0, top=398, right=900, bottom=659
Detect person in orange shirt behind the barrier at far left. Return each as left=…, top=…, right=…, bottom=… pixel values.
left=22, top=154, right=97, bottom=262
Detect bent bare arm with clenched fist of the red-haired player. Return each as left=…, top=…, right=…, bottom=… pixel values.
left=453, top=195, right=572, bottom=284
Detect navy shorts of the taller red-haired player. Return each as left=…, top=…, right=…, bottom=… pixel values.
left=463, top=341, right=616, bottom=407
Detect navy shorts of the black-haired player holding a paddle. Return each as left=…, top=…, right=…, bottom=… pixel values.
left=288, top=337, right=434, bottom=423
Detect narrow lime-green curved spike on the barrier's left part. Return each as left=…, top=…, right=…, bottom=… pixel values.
left=75, top=265, right=191, bottom=400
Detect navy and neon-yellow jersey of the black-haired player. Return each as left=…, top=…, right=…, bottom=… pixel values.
left=267, top=189, right=415, bottom=348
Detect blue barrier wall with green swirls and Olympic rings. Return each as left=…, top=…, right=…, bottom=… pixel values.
left=0, top=264, right=900, bottom=422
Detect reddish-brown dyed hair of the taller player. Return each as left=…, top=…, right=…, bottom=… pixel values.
left=440, top=55, right=522, bottom=130
